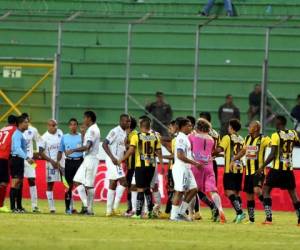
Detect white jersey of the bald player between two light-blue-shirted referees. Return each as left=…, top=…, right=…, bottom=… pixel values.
left=39, top=129, right=63, bottom=161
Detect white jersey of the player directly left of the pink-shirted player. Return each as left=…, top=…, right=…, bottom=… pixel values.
left=174, top=132, right=192, bottom=167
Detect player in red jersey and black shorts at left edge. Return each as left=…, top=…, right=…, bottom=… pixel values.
left=0, top=115, right=17, bottom=213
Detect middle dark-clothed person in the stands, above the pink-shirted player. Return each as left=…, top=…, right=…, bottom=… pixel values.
left=219, top=95, right=240, bottom=137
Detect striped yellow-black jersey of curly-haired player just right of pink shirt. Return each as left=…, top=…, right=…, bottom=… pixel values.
left=219, top=134, right=244, bottom=174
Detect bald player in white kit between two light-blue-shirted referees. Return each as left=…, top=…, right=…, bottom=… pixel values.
left=39, top=119, right=63, bottom=213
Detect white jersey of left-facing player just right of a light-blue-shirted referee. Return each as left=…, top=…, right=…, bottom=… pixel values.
left=83, top=123, right=100, bottom=156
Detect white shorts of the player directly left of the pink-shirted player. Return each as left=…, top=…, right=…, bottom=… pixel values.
left=172, top=164, right=197, bottom=192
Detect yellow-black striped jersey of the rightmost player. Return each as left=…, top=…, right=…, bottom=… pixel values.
left=271, top=129, right=299, bottom=171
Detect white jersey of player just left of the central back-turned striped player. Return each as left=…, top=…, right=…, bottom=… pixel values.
left=106, top=126, right=127, bottom=160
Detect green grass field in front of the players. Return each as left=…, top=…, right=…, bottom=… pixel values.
left=0, top=200, right=300, bottom=250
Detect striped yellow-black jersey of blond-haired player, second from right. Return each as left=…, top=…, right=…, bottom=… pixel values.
left=244, top=135, right=271, bottom=175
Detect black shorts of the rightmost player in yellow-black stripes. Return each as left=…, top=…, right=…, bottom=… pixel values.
left=265, top=169, right=296, bottom=190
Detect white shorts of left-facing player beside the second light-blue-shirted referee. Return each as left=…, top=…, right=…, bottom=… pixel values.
left=73, top=155, right=99, bottom=187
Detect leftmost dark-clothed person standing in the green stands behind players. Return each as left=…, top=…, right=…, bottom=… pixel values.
left=146, top=92, right=172, bottom=136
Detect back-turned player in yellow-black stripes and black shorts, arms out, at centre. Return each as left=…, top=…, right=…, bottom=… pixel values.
left=119, top=118, right=163, bottom=218
